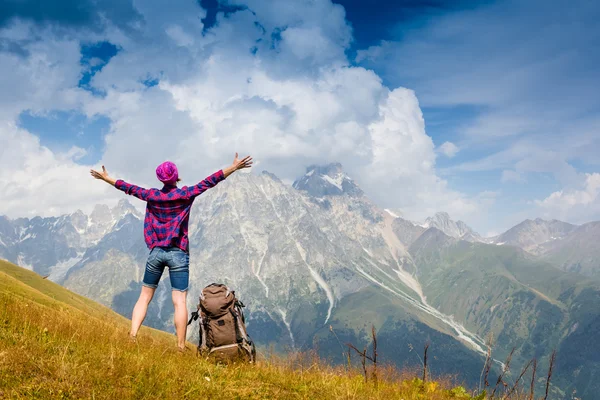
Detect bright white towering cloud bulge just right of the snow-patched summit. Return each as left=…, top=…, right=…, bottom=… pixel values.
left=361, top=88, right=489, bottom=222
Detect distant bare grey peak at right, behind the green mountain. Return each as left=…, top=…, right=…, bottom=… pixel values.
left=491, top=218, right=576, bottom=253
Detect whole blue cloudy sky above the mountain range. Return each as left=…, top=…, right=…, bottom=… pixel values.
left=0, top=0, right=600, bottom=236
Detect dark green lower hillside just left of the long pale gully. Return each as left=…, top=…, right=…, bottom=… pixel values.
left=314, top=287, right=490, bottom=387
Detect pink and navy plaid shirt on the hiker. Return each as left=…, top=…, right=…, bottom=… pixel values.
left=115, top=170, right=225, bottom=252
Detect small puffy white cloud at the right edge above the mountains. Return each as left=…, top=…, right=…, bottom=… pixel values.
left=535, top=173, right=600, bottom=222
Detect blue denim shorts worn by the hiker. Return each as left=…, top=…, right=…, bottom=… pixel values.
left=143, top=247, right=190, bottom=292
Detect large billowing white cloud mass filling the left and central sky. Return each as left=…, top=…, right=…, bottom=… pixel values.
left=0, top=0, right=495, bottom=227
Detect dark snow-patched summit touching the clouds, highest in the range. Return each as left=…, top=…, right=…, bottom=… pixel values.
left=293, top=163, right=363, bottom=198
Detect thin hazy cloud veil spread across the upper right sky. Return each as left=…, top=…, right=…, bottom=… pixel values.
left=357, top=0, right=600, bottom=223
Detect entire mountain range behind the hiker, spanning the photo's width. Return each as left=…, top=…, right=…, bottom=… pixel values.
left=0, top=164, right=600, bottom=398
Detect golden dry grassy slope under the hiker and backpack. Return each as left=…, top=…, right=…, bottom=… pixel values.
left=0, top=261, right=480, bottom=400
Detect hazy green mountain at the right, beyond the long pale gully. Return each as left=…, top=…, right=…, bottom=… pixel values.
left=410, top=229, right=600, bottom=399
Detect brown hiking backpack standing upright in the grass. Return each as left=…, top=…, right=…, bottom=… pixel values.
left=188, top=283, right=256, bottom=363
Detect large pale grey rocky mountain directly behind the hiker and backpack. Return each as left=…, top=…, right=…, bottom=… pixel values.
left=62, top=169, right=483, bottom=384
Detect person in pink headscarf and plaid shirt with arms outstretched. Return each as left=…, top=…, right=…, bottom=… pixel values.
left=90, top=153, right=252, bottom=350
